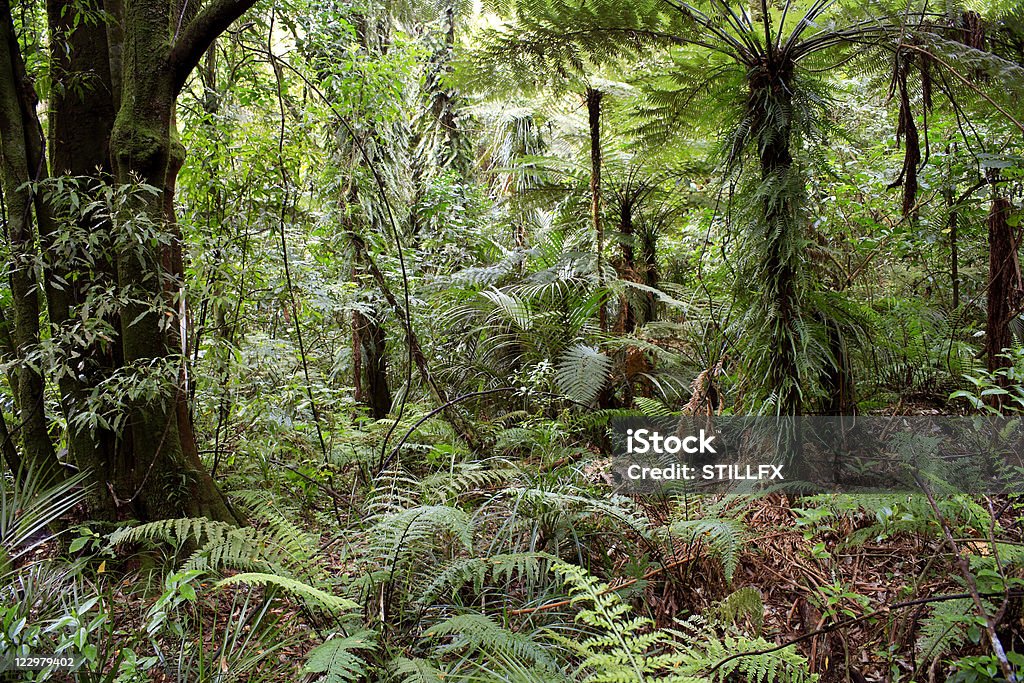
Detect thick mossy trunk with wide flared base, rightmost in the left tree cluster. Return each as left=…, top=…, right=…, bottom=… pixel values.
left=106, top=0, right=236, bottom=521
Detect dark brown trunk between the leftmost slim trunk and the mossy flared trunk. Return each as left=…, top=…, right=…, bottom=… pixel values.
left=41, top=0, right=121, bottom=507
